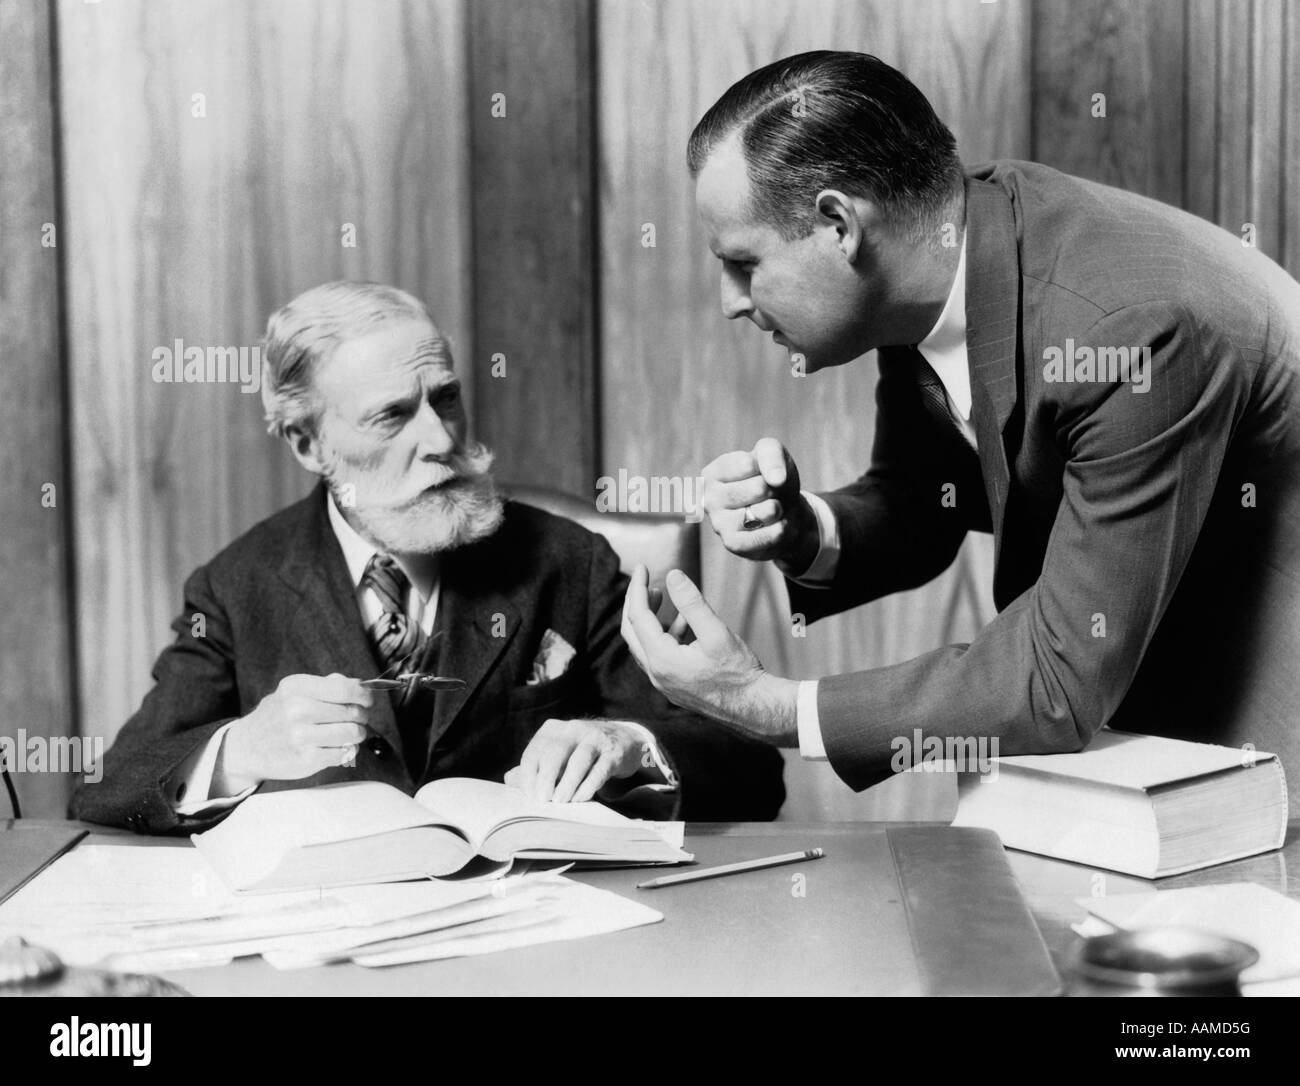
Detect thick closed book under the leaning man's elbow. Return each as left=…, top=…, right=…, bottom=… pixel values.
left=953, top=730, right=1287, bottom=879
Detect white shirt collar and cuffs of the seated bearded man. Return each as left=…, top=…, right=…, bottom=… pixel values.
left=168, top=494, right=677, bottom=815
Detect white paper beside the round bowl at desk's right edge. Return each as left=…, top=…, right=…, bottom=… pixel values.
left=1078, top=882, right=1300, bottom=986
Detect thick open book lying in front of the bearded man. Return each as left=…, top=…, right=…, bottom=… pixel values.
left=192, top=778, right=690, bottom=892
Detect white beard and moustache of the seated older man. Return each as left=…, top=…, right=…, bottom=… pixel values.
left=322, top=444, right=506, bottom=554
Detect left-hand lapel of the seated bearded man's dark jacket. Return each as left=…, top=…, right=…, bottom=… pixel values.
left=280, top=486, right=402, bottom=750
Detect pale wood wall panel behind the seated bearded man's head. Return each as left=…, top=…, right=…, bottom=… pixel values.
left=59, top=0, right=472, bottom=736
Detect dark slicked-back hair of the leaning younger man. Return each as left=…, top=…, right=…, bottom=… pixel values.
left=686, top=49, right=962, bottom=241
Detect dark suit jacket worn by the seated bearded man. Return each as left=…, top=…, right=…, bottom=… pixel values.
left=72, top=488, right=785, bottom=832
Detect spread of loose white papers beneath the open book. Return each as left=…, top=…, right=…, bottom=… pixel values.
left=0, top=845, right=663, bottom=972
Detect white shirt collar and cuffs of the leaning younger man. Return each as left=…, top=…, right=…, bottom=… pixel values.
left=793, top=230, right=979, bottom=761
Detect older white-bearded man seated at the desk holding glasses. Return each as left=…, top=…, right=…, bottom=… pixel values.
left=72, top=282, right=784, bottom=832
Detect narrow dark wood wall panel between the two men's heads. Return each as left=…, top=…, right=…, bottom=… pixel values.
left=469, top=0, right=599, bottom=494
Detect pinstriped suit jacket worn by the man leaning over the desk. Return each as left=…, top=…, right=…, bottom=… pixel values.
left=790, top=163, right=1300, bottom=802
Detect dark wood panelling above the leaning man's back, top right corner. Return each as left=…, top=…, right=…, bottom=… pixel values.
left=1032, top=0, right=1300, bottom=274
